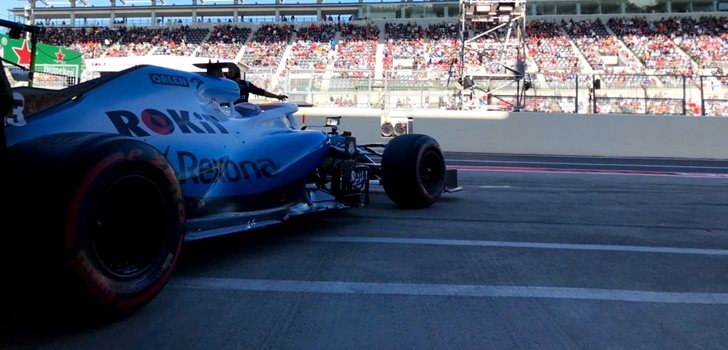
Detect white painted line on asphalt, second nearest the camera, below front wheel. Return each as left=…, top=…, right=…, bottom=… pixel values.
left=296, top=236, right=728, bottom=256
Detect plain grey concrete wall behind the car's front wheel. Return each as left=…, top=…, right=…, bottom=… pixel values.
left=296, top=107, right=728, bottom=160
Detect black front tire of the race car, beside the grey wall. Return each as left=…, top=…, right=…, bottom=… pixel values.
left=382, top=134, right=446, bottom=208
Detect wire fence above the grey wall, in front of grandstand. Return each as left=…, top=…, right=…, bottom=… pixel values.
left=267, top=69, right=728, bottom=116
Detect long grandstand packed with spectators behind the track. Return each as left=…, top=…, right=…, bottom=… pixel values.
left=4, top=0, right=728, bottom=116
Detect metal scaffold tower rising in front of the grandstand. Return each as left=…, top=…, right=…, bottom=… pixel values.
left=458, top=0, right=531, bottom=111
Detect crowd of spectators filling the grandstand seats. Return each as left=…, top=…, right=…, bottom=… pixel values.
left=15, top=17, right=728, bottom=115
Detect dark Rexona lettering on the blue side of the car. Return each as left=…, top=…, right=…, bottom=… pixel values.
left=177, top=151, right=278, bottom=185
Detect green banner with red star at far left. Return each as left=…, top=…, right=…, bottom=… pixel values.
left=0, top=34, right=83, bottom=78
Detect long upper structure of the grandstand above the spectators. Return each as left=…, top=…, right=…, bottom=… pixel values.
left=11, top=0, right=728, bottom=26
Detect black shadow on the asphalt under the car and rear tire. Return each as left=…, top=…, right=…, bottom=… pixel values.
left=0, top=213, right=346, bottom=348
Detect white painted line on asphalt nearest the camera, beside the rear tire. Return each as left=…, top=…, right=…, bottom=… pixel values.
left=170, top=277, right=728, bottom=305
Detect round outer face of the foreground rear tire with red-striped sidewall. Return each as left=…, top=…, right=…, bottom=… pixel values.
left=64, top=141, right=184, bottom=312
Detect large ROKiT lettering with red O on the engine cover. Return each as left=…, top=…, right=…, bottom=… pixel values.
left=106, top=108, right=230, bottom=137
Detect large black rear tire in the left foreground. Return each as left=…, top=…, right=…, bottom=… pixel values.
left=3, top=134, right=185, bottom=317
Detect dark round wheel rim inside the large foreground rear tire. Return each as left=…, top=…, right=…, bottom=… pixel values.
left=91, top=175, right=167, bottom=279
